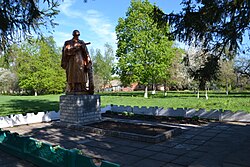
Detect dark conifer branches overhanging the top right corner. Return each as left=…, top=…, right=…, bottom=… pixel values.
left=153, top=0, right=250, bottom=57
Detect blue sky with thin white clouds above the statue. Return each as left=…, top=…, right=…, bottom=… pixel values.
left=48, top=0, right=182, bottom=52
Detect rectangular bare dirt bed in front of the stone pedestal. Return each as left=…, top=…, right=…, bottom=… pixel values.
left=88, top=121, right=174, bottom=136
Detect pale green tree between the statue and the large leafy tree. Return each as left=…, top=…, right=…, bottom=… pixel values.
left=91, top=43, right=114, bottom=91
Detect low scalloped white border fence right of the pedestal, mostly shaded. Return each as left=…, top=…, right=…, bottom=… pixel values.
left=106, top=105, right=250, bottom=122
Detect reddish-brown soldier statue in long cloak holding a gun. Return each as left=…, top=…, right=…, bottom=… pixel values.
left=61, top=30, right=94, bottom=94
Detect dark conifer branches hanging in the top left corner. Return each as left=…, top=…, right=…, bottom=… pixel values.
left=0, top=0, right=59, bottom=52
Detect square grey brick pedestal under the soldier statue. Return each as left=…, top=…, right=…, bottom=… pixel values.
left=60, top=95, right=101, bottom=126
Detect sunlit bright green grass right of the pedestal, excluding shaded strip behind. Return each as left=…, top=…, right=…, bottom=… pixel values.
left=101, top=96, right=250, bottom=112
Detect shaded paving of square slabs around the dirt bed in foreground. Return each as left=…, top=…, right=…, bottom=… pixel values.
left=0, top=122, right=250, bottom=167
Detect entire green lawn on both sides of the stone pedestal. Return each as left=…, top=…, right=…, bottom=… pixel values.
left=0, top=92, right=250, bottom=116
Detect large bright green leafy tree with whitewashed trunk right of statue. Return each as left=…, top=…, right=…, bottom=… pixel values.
left=116, top=0, right=174, bottom=97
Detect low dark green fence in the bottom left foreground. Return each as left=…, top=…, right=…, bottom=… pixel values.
left=0, top=130, right=120, bottom=167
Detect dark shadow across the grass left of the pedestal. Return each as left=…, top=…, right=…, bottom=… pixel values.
left=0, top=100, right=59, bottom=116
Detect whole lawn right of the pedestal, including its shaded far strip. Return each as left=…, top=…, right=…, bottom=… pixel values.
left=101, top=91, right=250, bottom=112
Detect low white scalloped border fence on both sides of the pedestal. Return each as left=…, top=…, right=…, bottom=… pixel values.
left=0, top=105, right=250, bottom=128
